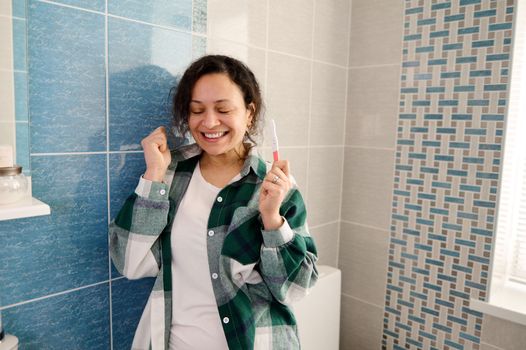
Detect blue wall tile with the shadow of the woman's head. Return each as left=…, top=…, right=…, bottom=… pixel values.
left=109, top=18, right=192, bottom=151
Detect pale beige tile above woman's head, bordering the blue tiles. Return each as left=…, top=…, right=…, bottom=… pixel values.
left=207, top=0, right=267, bottom=48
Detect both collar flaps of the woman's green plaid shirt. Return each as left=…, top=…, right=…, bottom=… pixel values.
left=169, top=143, right=267, bottom=180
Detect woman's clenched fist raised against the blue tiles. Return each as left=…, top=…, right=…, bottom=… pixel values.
left=141, top=126, right=172, bottom=182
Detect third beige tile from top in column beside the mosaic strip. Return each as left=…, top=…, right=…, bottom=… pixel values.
left=342, top=147, right=395, bottom=230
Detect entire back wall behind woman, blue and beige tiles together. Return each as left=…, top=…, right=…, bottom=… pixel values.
left=0, top=0, right=350, bottom=349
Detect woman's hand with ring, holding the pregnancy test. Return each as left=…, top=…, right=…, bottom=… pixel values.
left=259, top=160, right=292, bottom=230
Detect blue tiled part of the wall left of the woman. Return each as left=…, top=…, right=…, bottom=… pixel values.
left=0, top=0, right=206, bottom=349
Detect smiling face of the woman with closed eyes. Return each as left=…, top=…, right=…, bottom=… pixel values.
left=188, top=73, right=252, bottom=160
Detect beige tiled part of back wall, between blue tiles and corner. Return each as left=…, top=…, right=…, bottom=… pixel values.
left=207, top=0, right=350, bottom=266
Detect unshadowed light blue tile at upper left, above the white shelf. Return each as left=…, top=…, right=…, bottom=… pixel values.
left=28, top=1, right=106, bottom=153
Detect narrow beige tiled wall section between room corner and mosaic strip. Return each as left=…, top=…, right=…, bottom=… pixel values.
left=339, top=0, right=404, bottom=350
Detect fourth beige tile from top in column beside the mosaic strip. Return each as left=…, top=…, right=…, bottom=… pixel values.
left=339, top=222, right=389, bottom=306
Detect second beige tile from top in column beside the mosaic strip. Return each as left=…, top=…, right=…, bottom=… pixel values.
left=345, top=65, right=400, bottom=149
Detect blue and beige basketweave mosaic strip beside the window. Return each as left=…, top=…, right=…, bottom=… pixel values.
left=382, top=0, right=514, bottom=349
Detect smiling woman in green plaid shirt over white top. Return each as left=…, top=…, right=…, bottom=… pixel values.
left=110, top=56, right=317, bottom=350
